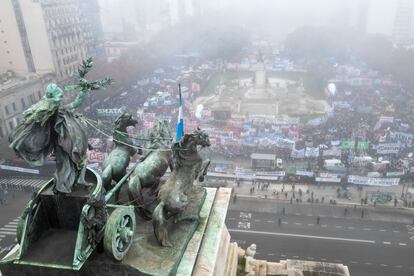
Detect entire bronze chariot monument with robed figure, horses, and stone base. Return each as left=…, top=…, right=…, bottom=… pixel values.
left=0, top=60, right=349, bottom=276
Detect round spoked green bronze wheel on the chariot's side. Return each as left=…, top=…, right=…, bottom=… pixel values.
left=104, top=207, right=136, bottom=261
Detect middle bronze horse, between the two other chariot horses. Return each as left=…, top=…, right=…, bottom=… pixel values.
left=128, top=120, right=173, bottom=220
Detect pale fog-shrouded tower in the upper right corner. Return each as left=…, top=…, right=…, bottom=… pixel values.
left=392, top=0, right=414, bottom=45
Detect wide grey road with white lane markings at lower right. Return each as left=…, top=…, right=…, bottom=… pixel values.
left=226, top=209, right=414, bottom=276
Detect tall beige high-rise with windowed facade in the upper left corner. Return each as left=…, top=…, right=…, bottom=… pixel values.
left=0, top=0, right=96, bottom=81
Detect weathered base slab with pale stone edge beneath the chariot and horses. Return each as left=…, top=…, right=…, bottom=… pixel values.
left=0, top=187, right=231, bottom=276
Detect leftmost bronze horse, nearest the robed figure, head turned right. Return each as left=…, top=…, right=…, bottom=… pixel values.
left=102, top=111, right=138, bottom=201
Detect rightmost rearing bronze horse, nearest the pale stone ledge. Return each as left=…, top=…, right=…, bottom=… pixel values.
left=152, top=129, right=210, bottom=246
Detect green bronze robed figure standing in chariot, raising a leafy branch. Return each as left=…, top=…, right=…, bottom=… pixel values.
left=9, top=59, right=112, bottom=193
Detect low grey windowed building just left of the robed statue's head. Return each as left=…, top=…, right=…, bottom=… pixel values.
left=0, top=71, right=55, bottom=140
